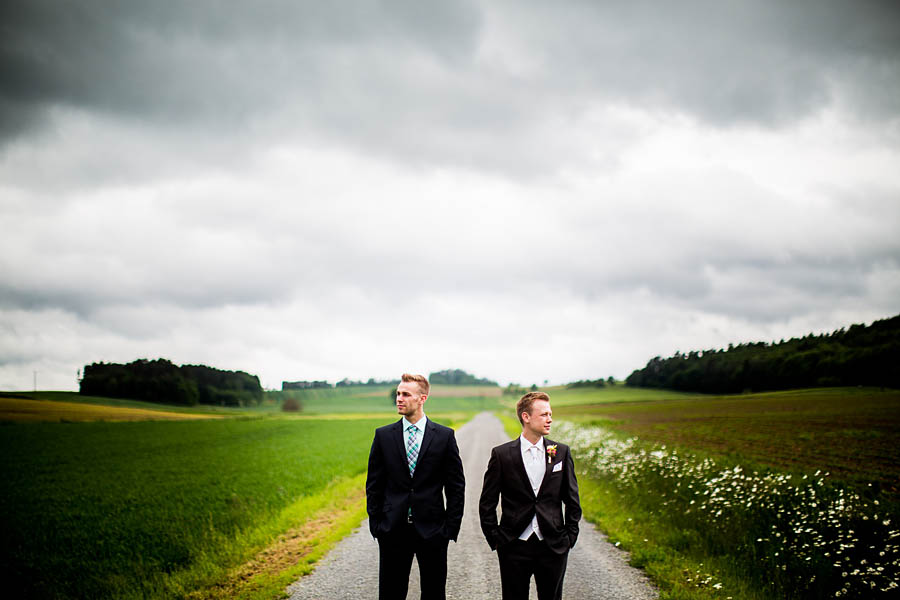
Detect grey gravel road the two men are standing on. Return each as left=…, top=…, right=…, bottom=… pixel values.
left=287, top=413, right=658, bottom=600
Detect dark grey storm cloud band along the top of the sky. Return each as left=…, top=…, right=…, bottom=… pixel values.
left=0, top=1, right=900, bottom=164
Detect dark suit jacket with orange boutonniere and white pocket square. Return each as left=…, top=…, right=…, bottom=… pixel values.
left=478, top=438, right=581, bottom=554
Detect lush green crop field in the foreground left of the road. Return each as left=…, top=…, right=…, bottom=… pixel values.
left=0, top=415, right=393, bottom=598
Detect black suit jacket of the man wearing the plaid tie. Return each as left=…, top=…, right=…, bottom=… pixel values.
left=366, top=419, right=466, bottom=541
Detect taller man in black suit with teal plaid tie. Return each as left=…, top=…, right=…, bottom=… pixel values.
left=366, top=374, right=466, bottom=600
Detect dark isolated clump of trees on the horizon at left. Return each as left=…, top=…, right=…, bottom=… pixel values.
left=79, top=358, right=263, bottom=406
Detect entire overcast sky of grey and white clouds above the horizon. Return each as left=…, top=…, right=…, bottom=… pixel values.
left=0, top=0, right=900, bottom=390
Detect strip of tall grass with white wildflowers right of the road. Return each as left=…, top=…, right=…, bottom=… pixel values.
left=554, top=423, right=900, bottom=598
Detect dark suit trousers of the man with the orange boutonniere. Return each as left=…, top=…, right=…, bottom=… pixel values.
left=497, top=534, right=569, bottom=600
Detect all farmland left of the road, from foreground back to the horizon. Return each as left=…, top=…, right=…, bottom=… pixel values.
left=0, top=386, right=488, bottom=598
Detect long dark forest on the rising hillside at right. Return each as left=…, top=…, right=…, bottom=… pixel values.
left=625, top=315, right=900, bottom=394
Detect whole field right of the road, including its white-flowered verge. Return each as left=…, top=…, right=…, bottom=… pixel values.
left=551, top=388, right=900, bottom=600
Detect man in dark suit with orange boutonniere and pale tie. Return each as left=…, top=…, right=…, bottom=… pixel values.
left=478, top=392, right=581, bottom=600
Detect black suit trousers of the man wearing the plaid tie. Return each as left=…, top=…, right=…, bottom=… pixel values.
left=378, top=524, right=450, bottom=600
